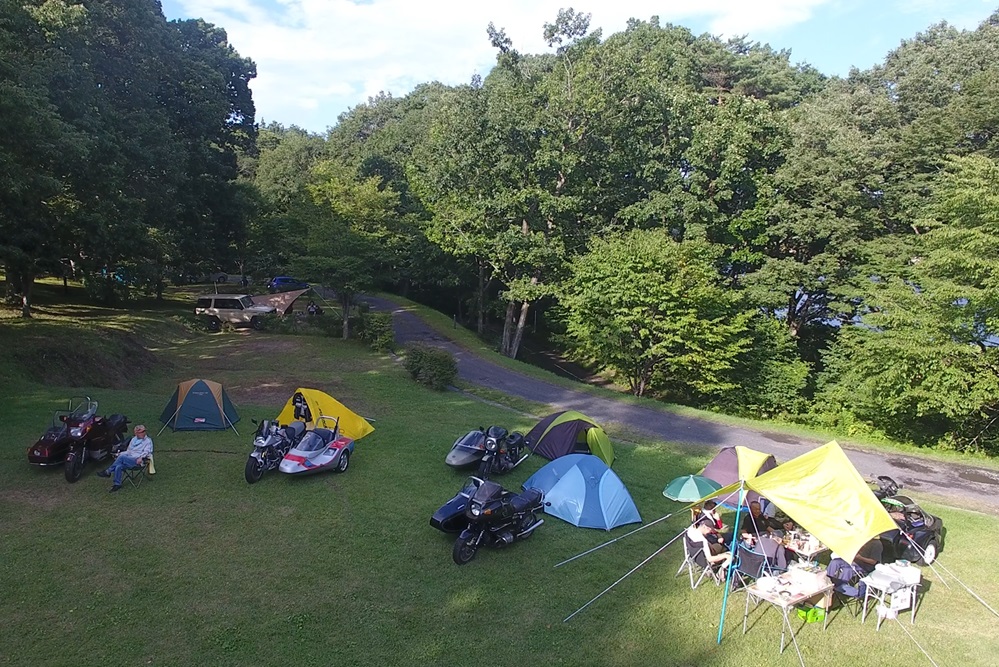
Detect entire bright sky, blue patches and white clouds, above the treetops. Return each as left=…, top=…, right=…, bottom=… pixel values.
left=162, top=0, right=999, bottom=132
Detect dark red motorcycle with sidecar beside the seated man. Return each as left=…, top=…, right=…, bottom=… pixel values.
left=28, top=396, right=128, bottom=483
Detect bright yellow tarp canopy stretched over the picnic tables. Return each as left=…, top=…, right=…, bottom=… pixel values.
left=703, top=441, right=898, bottom=561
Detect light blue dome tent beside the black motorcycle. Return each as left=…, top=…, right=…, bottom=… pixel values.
left=524, top=454, right=642, bottom=530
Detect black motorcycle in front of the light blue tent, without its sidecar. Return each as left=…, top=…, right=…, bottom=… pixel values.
left=451, top=479, right=545, bottom=565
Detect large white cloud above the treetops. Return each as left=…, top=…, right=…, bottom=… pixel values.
left=175, top=0, right=830, bottom=130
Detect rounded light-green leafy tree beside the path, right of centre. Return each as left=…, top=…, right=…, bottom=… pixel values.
left=562, top=229, right=753, bottom=397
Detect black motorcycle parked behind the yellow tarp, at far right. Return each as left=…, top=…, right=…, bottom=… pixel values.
left=874, top=475, right=944, bottom=565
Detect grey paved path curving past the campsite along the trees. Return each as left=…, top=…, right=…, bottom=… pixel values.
left=364, top=297, right=999, bottom=514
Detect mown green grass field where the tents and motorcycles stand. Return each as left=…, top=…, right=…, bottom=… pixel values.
left=0, top=288, right=999, bottom=667
